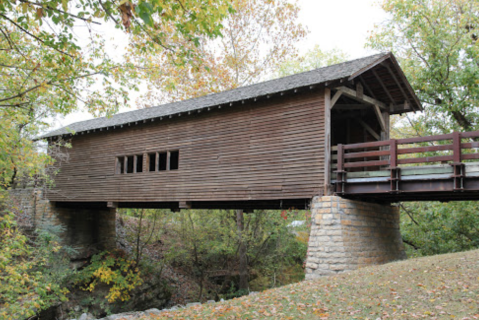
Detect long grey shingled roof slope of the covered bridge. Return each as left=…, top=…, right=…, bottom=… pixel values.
left=39, top=53, right=402, bottom=139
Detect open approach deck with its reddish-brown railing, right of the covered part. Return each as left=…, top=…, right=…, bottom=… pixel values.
left=332, top=131, right=479, bottom=202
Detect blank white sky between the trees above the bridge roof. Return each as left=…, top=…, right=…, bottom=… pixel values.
left=51, top=0, right=387, bottom=130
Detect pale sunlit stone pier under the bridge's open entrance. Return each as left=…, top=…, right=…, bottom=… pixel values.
left=306, top=196, right=406, bottom=280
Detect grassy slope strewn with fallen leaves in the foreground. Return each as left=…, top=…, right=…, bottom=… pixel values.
left=143, top=250, right=479, bottom=320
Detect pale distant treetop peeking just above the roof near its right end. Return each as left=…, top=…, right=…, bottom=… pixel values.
left=274, top=45, right=349, bottom=78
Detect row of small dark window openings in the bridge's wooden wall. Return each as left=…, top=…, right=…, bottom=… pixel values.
left=116, top=150, right=180, bottom=173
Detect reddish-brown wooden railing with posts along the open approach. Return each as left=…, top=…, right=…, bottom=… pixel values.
left=332, top=131, right=479, bottom=193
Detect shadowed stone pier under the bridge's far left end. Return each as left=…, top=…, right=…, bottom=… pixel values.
left=10, top=189, right=116, bottom=260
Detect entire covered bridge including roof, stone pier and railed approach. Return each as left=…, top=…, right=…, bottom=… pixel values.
left=36, top=53, right=479, bottom=279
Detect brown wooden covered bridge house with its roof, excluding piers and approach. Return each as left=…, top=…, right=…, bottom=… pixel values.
left=42, top=54, right=421, bottom=209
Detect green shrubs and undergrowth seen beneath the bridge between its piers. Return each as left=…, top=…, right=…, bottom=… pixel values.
left=167, top=210, right=309, bottom=296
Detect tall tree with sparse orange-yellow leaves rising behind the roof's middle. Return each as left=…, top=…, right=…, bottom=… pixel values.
left=129, top=0, right=307, bottom=107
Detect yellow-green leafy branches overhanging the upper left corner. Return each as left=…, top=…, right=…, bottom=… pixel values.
left=0, top=0, right=233, bottom=189
